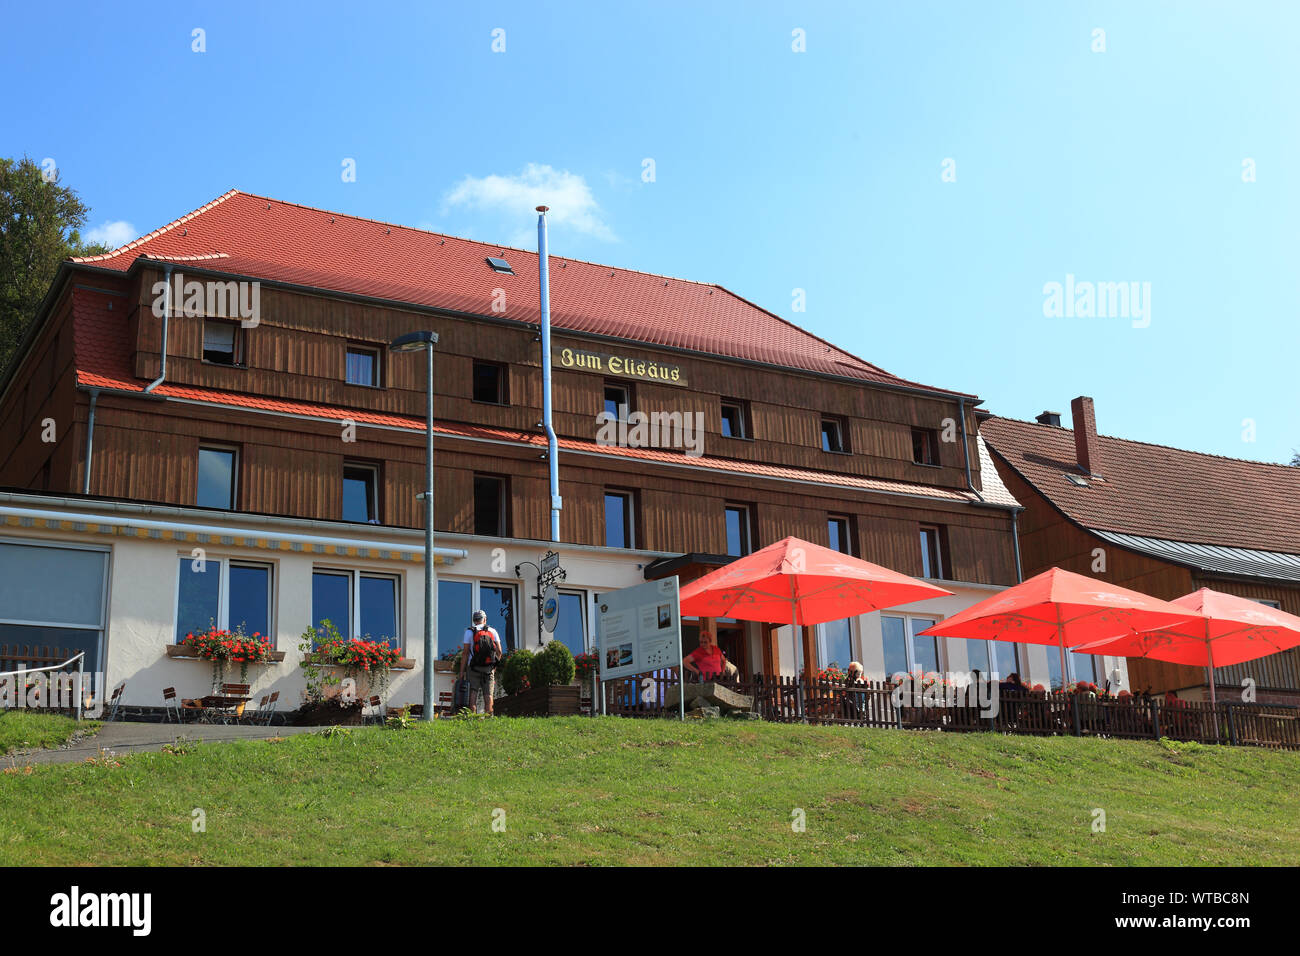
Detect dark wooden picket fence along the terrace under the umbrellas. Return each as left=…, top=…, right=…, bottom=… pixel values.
left=595, top=671, right=1300, bottom=750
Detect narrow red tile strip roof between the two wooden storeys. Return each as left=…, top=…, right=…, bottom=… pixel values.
left=73, top=289, right=975, bottom=502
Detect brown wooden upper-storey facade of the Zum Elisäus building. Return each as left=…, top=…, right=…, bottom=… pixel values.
left=0, top=264, right=1015, bottom=584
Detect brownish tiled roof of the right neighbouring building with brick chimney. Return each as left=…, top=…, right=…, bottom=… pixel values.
left=980, top=416, right=1300, bottom=561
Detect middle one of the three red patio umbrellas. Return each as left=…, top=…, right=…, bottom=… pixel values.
left=922, top=567, right=1193, bottom=684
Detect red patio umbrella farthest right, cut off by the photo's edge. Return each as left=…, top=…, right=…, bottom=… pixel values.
left=1078, top=588, right=1300, bottom=704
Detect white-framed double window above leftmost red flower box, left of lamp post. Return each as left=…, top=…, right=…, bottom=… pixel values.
left=176, top=557, right=273, bottom=644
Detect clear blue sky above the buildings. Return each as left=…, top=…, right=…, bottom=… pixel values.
left=0, top=0, right=1300, bottom=460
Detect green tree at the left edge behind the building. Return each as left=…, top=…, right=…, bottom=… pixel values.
left=0, top=156, right=108, bottom=371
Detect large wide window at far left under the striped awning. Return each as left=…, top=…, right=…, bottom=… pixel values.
left=0, top=541, right=108, bottom=674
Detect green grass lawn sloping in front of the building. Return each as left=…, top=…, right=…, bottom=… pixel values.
left=0, top=718, right=1300, bottom=866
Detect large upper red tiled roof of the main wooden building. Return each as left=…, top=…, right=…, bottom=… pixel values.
left=72, top=190, right=974, bottom=398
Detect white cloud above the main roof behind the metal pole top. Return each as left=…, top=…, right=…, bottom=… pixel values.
left=443, top=163, right=618, bottom=242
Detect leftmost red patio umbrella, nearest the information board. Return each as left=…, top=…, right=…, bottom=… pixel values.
left=681, top=537, right=953, bottom=676
